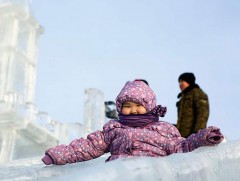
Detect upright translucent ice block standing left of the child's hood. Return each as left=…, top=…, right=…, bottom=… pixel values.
left=84, top=88, right=105, bottom=131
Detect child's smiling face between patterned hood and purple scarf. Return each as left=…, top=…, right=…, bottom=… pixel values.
left=122, top=101, right=147, bottom=115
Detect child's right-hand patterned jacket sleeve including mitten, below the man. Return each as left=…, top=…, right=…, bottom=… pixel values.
left=173, top=126, right=224, bottom=153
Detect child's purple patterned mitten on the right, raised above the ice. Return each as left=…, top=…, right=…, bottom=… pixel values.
left=204, top=126, right=224, bottom=145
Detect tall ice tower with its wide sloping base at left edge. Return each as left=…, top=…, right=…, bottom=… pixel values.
left=0, top=0, right=58, bottom=162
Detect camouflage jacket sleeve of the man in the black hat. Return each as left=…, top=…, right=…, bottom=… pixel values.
left=193, top=91, right=209, bottom=133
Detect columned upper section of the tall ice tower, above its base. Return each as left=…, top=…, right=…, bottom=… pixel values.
left=0, top=1, right=38, bottom=104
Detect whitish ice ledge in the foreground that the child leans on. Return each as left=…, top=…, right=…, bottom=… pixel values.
left=0, top=140, right=240, bottom=181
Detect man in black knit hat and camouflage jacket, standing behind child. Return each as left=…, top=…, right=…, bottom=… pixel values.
left=176, top=72, right=209, bottom=138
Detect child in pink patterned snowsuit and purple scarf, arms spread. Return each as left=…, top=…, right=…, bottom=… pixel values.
left=42, top=80, right=223, bottom=165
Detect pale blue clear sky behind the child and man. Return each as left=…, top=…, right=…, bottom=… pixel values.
left=31, top=0, right=240, bottom=139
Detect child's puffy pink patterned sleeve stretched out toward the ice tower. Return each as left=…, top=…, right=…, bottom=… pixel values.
left=45, top=131, right=108, bottom=165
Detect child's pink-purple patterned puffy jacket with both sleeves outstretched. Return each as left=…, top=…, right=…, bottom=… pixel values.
left=43, top=120, right=223, bottom=165
